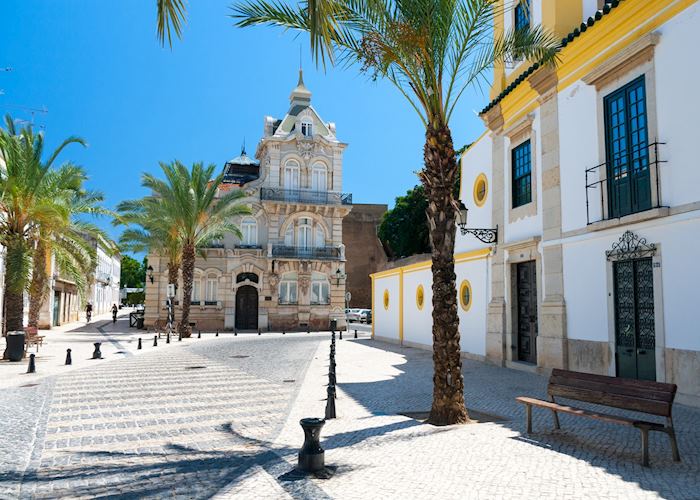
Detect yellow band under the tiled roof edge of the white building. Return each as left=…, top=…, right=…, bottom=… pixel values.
left=491, top=0, right=697, bottom=128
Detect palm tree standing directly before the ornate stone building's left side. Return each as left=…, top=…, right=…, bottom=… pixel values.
left=125, top=161, right=250, bottom=337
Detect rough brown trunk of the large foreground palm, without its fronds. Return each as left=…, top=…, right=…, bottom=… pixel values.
left=421, top=124, right=469, bottom=425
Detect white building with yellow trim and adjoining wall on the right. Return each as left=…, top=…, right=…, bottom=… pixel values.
left=373, top=0, right=700, bottom=405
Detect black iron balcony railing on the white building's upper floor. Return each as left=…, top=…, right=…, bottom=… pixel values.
left=586, top=142, right=667, bottom=225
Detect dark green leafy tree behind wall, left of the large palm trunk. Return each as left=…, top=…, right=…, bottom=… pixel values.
left=379, top=186, right=430, bottom=259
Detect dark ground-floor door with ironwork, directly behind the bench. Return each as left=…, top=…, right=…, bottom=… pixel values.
left=613, top=257, right=656, bottom=380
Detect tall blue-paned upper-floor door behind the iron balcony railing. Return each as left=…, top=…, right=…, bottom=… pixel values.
left=605, top=76, right=651, bottom=217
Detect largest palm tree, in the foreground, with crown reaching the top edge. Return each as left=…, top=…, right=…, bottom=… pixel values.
left=153, top=0, right=558, bottom=425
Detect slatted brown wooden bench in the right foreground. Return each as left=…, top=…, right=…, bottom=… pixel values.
left=515, top=369, right=681, bottom=467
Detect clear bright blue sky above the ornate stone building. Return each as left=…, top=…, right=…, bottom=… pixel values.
left=0, top=0, right=487, bottom=246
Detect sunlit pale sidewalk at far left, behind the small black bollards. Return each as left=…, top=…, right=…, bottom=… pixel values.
left=0, top=309, right=197, bottom=388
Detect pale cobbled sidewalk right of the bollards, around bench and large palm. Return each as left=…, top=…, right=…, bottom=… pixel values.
left=256, top=340, right=700, bottom=499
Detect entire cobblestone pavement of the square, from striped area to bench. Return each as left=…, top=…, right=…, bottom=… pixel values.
left=0, top=335, right=700, bottom=499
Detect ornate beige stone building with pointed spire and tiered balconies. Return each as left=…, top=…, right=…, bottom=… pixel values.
left=145, top=72, right=352, bottom=331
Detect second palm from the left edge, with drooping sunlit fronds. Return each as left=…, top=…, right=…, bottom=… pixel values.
left=28, top=168, right=116, bottom=326
